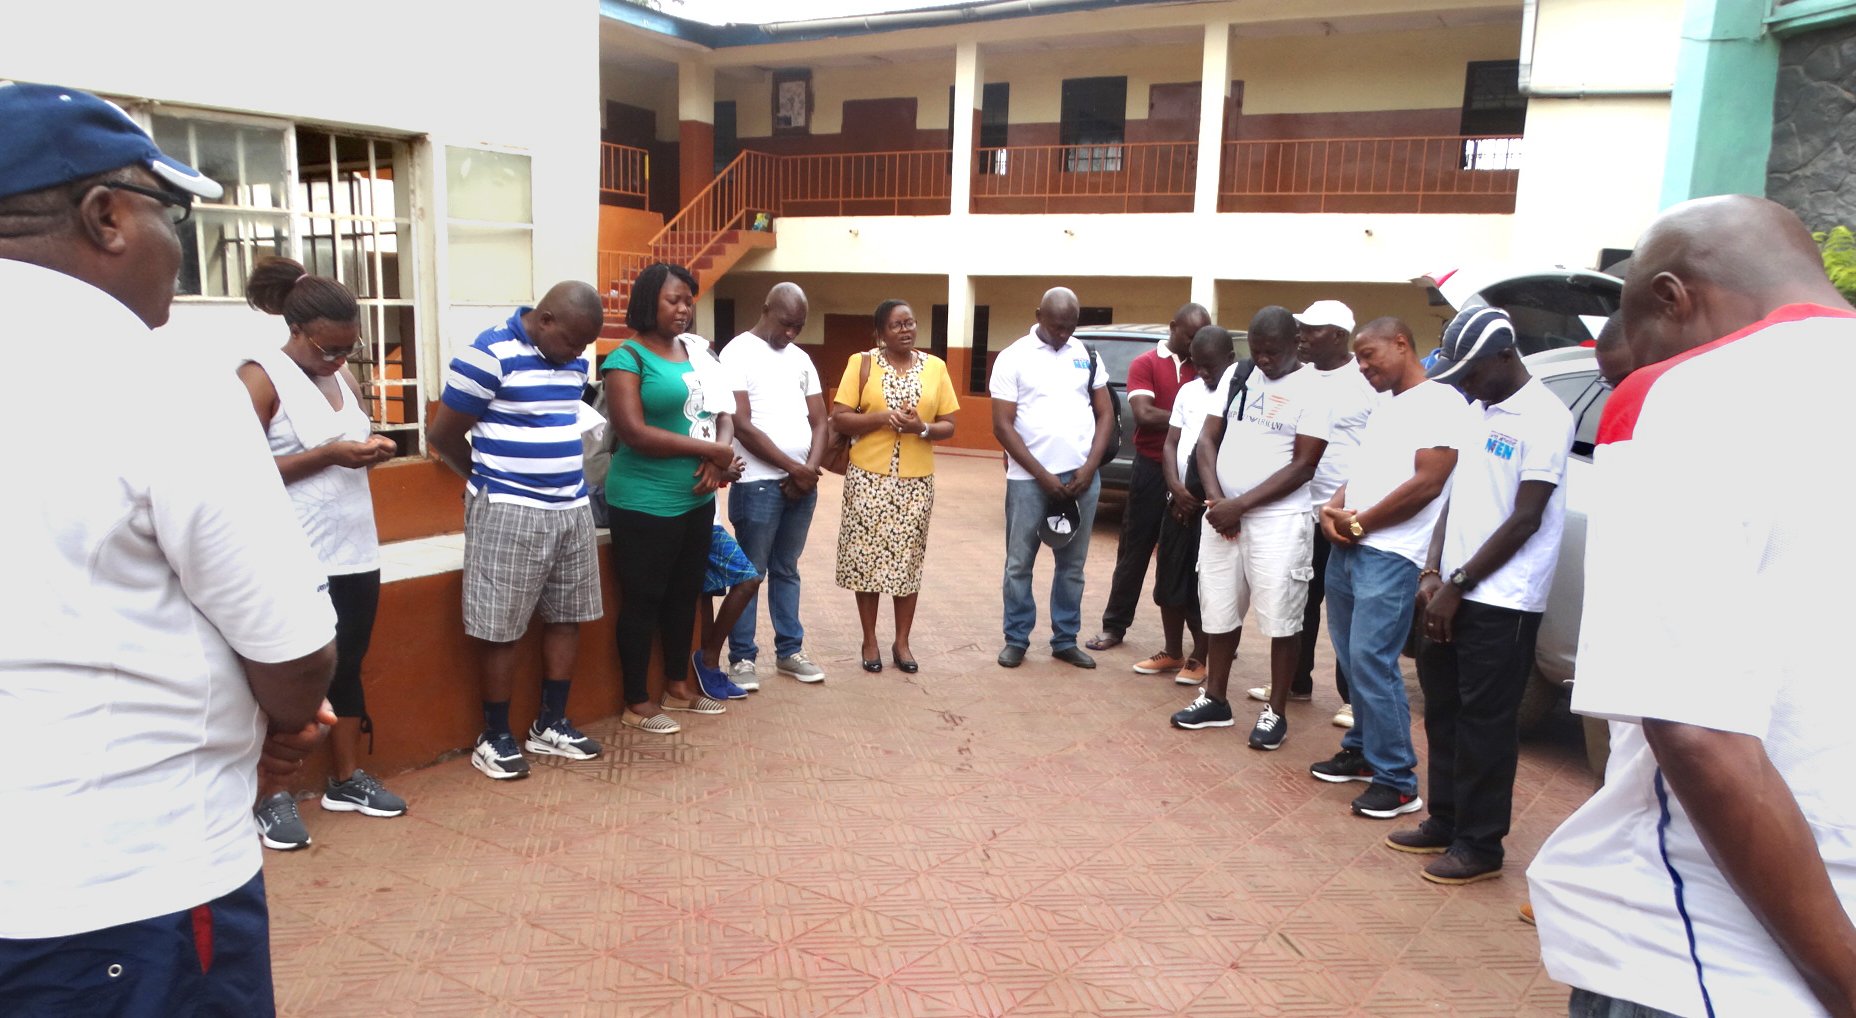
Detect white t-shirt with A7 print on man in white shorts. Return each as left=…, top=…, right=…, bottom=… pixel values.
left=1212, top=368, right=1331, bottom=516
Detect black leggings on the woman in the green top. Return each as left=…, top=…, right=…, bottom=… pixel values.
left=609, top=502, right=715, bottom=706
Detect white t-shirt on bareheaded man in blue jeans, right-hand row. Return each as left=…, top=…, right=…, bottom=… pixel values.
left=1347, top=379, right=1468, bottom=565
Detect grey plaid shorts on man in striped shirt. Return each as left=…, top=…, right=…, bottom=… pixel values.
left=464, top=496, right=603, bottom=643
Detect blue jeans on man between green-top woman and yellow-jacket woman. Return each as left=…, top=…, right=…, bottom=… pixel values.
left=728, top=481, right=818, bottom=661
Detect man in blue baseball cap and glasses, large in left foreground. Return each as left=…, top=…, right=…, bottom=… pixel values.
left=0, top=82, right=334, bottom=1016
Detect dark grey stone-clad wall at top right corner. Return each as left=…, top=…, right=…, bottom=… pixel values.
left=1765, top=24, right=1856, bottom=230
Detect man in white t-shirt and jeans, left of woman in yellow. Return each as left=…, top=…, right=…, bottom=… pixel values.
left=722, top=282, right=824, bottom=691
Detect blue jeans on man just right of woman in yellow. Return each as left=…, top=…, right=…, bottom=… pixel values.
left=1004, top=470, right=1102, bottom=650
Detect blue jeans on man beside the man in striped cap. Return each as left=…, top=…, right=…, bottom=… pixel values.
left=1327, top=546, right=1418, bottom=795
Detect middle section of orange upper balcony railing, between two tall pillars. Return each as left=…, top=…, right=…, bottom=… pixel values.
left=973, top=141, right=1199, bottom=212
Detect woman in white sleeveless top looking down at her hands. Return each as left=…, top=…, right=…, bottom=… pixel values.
left=238, top=258, right=406, bottom=851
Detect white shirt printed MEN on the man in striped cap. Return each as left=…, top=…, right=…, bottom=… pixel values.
left=1442, top=379, right=1572, bottom=611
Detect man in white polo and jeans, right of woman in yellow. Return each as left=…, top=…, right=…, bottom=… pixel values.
left=987, top=286, right=1115, bottom=669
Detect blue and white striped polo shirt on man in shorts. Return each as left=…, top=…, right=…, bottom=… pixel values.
left=444, top=308, right=590, bottom=509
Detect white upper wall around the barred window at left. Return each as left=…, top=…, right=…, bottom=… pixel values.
left=0, top=0, right=601, bottom=367
